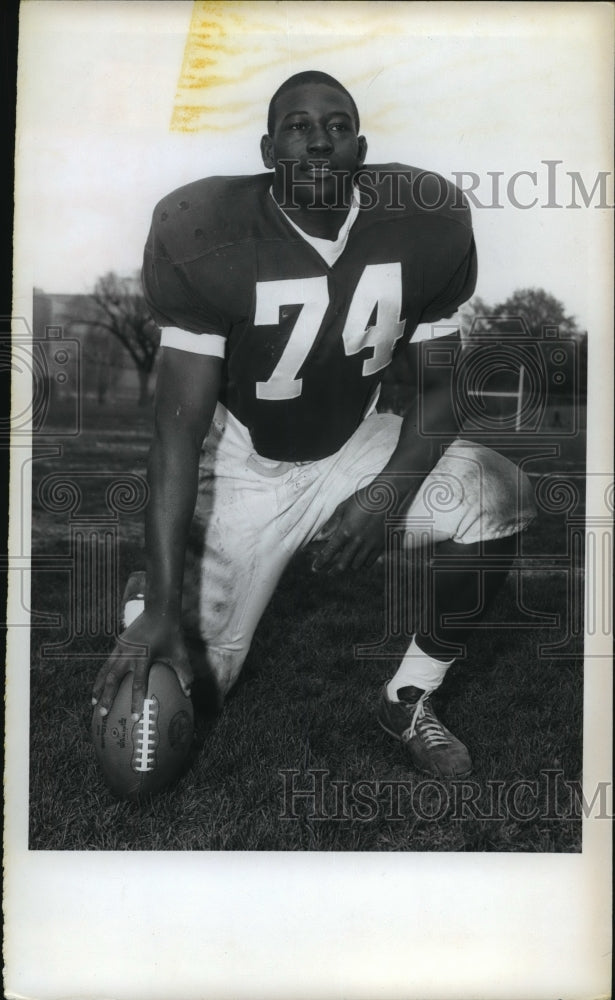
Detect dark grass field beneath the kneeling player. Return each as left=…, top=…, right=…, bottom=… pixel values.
left=30, top=394, right=583, bottom=852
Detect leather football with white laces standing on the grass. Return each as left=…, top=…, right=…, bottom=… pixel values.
left=92, top=663, right=194, bottom=801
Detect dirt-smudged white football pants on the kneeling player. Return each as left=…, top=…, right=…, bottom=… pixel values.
left=177, top=406, right=534, bottom=695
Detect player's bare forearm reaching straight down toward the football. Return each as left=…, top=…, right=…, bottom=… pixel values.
left=145, top=432, right=200, bottom=623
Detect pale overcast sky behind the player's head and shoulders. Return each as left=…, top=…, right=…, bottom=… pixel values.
left=16, top=0, right=612, bottom=325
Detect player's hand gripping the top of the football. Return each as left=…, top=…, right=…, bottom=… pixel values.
left=92, top=611, right=193, bottom=718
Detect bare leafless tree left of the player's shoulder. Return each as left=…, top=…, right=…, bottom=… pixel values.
left=85, top=271, right=160, bottom=406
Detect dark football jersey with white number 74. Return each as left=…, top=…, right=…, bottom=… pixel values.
left=143, top=164, right=476, bottom=461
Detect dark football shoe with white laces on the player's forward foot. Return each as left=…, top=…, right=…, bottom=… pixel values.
left=377, top=685, right=472, bottom=778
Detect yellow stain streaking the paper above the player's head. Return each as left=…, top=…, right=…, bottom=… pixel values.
left=171, top=0, right=414, bottom=132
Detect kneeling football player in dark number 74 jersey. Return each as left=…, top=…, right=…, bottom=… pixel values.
left=93, top=72, right=534, bottom=777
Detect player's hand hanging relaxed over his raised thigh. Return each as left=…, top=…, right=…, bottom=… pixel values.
left=312, top=490, right=385, bottom=574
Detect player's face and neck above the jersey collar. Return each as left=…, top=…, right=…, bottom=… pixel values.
left=261, top=84, right=367, bottom=206
